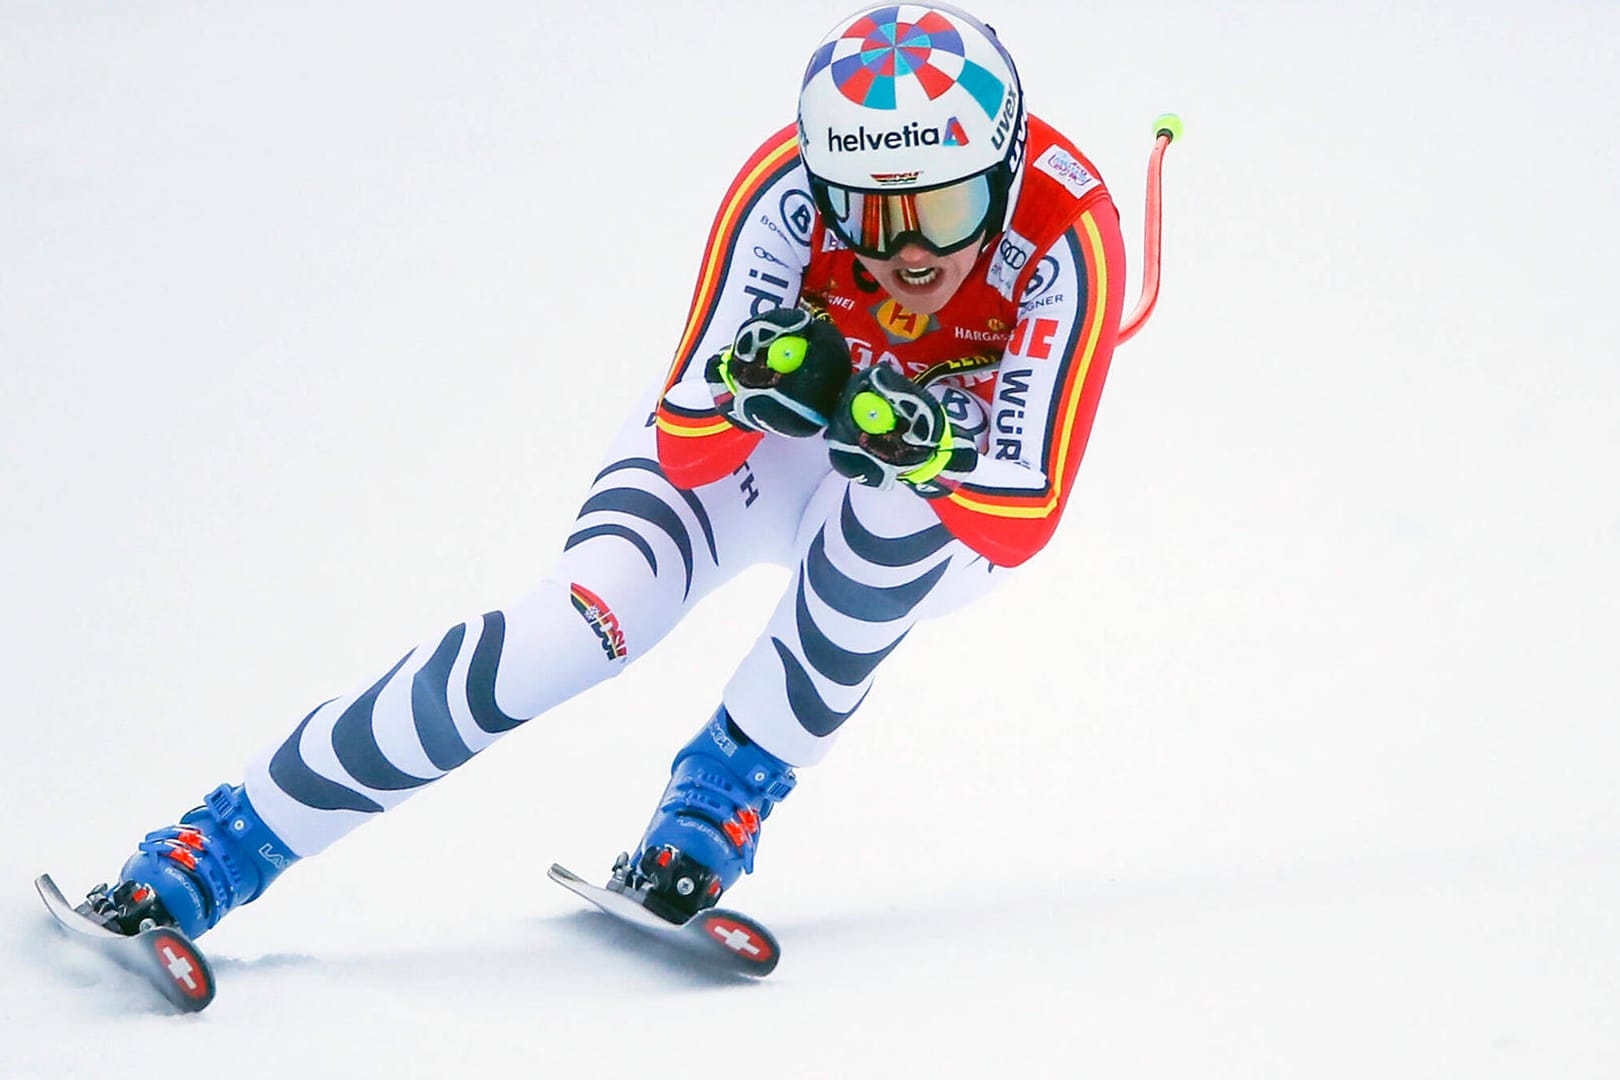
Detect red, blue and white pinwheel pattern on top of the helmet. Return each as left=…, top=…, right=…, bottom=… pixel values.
left=805, top=6, right=1006, bottom=117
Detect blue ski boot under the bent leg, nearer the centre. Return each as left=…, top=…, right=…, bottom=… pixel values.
left=614, top=706, right=797, bottom=923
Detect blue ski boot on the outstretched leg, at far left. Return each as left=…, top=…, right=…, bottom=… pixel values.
left=79, top=784, right=298, bottom=938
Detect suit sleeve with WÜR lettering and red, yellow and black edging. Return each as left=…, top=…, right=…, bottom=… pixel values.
left=932, top=207, right=1124, bottom=567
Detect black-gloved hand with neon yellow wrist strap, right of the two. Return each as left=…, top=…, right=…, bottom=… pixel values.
left=826, top=364, right=978, bottom=497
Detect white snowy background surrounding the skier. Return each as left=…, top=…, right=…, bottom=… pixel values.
left=0, top=0, right=1620, bottom=1080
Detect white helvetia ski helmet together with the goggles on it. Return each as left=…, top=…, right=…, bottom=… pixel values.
left=799, top=3, right=1027, bottom=259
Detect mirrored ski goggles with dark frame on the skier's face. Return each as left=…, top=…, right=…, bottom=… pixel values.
left=810, top=167, right=1006, bottom=259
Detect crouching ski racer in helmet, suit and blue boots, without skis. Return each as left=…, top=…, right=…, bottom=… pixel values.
left=83, top=3, right=1124, bottom=938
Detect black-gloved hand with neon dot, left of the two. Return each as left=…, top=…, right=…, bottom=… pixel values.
left=705, top=308, right=851, bottom=439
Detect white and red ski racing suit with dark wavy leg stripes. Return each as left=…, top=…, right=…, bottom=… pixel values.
left=246, top=117, right=1124, bottom=855
